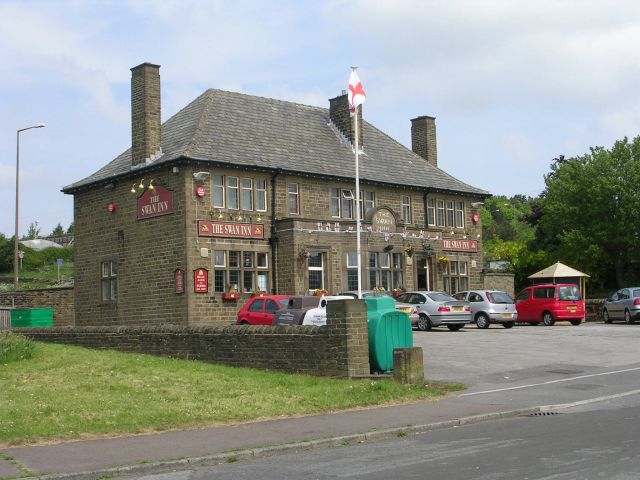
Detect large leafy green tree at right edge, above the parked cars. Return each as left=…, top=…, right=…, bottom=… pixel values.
left=538, top=136, right=640, bottom=286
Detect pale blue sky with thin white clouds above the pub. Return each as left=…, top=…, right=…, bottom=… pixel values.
left=0, top=0, right=640, bottom=237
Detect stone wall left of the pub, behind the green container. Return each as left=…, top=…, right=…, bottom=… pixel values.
left=0, top=287, right=74, bottom=327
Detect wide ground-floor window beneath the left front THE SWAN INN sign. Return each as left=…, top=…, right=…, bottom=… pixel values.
left=213, top=250, right=269, bottom=293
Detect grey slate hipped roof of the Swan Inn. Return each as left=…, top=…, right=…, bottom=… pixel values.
left=63, top=89, right=489, bottom=197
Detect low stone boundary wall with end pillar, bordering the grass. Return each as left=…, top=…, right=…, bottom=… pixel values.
left=16, top=300, right=370, bottom=378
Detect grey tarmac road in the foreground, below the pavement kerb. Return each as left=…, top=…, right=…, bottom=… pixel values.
left=130, top=396, right=640, bottom=480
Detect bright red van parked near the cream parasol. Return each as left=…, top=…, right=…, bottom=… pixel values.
left=516, top=283, right=584, bottom=326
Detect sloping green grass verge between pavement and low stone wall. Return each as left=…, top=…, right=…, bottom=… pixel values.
left=0, top=342, right=463, bottom=445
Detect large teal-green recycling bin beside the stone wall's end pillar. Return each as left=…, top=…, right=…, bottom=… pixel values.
left=364, top=295, right=413, bottom=372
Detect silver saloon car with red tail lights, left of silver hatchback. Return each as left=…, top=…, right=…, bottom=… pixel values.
left=396, top=291, right=471, bottom=331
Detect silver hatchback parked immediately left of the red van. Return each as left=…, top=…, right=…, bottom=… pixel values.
left=453, top=290, right=518, bottom=328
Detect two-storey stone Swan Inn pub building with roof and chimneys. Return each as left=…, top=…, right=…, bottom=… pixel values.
left=63, top=63, right=489, bottom=326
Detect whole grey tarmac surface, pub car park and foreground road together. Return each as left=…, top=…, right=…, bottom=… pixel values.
left=124, top=323, right=640, bottom=480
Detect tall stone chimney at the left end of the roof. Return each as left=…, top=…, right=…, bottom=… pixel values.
left=131, top=63, right=161, bottom=166
